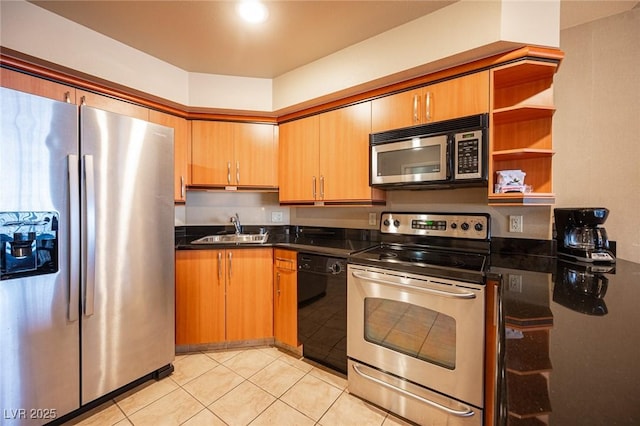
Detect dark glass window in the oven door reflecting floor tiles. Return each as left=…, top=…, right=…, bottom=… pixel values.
left=364, top=297, right=456, bottom=370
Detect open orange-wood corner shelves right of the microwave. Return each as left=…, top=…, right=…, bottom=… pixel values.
left=489, top=59, right=558, bottom=205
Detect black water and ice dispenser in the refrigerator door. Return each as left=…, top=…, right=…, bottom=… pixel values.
left=0, top=212, right=58, bottom=280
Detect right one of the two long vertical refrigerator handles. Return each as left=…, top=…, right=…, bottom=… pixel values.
left=83, top=155, right=96, bottom=316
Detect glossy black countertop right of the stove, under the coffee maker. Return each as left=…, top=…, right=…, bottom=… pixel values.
left=491, top=254, right=640, bottom=426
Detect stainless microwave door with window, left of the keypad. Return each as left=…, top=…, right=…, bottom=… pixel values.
left=371, top=135, right=450, bottom=185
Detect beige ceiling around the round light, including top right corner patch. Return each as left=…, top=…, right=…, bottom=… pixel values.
left=31, top=0, right=639, bottom=78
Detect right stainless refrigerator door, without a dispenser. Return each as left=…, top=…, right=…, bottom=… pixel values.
left=80, top=106, right=175, bottom=404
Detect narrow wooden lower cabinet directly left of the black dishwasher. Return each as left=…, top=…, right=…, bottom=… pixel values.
left=273, top=249, right=298, bottom=349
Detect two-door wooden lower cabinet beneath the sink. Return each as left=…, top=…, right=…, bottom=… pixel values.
left=176, top=248, right=273, bottom=345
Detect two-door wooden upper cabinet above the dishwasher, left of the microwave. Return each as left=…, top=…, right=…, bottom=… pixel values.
left=279, top=102, right=384, bottom=204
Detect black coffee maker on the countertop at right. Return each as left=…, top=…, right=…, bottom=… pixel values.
left=553, top=207, right=616, bottom=263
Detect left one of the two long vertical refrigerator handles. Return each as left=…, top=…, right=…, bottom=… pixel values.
left=67, top=154, right=80, bottom=322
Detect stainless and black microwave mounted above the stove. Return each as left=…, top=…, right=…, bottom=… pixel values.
left=369, top=114, right=489, bottom=189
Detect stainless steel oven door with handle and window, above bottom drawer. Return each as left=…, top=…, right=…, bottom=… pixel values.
left=347, top=264, right=485, bottom=408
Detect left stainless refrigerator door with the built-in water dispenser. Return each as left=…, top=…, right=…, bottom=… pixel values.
left=0, top=88, right=80, bottom=425
